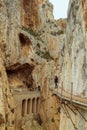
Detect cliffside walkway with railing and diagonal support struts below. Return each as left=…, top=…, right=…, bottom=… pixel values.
left=51, top=84, right=87, bottom=130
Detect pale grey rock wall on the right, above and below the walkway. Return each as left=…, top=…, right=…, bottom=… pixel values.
left=59, top=0, right=87, bottom=130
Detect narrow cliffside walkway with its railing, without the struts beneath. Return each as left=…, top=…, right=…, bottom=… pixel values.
left=50, top=83, right=87, bottom=107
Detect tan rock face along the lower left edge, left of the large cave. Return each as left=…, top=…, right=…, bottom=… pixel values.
left=0, top=51, right=15, bottom=130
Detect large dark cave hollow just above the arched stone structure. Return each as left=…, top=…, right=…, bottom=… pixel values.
left=6, top=63, right=34, bottom=90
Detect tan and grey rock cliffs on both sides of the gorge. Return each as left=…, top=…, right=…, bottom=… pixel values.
left=0, top=0, right=87, bottom=130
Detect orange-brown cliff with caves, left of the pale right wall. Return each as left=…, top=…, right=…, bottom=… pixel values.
left=0, top=0, right=66, bottom=130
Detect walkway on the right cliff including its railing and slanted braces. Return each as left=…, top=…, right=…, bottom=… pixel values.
left=53, top=83, right=87, bottom=130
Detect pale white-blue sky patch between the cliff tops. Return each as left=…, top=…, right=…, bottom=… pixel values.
left=49, top=0, right=69, bottom=19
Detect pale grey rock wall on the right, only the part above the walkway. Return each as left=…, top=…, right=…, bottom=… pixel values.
left=63, top=0, right=87, bottom=97
